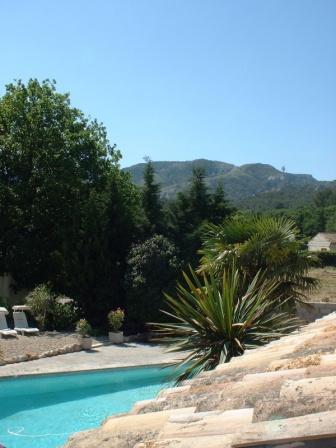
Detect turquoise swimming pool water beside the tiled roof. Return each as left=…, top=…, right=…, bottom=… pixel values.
left=0, top=367, right=177, bottom=448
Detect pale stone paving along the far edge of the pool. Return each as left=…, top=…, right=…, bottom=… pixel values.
left=0, top=343, right=183, bottom=378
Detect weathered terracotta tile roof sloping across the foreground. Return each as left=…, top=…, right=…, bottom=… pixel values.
left=66, top=313, right=336, bottom=448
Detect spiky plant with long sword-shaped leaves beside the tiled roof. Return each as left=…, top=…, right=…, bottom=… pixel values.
left=154, top=265, right=299, bottom=382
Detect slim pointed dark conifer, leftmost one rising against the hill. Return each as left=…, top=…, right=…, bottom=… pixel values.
left=142, top=158, right=163, bottom=235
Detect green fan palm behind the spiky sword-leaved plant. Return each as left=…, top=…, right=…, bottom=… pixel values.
left=198, top=216, right=318, bottom=302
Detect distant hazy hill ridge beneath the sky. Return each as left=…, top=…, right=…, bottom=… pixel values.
left=125, top=159, right=333, bottom=209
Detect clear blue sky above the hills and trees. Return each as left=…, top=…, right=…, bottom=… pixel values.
left=0, top=0, right=336, bottom=180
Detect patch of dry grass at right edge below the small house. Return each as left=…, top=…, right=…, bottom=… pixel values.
left=308, top=266, right=336, bottom=303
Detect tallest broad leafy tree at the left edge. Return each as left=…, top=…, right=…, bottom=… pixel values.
left=0, top=80, right=113, bottom=288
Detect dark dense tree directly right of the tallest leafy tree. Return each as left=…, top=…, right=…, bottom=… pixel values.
left=62, top=167, right=144, bottom=328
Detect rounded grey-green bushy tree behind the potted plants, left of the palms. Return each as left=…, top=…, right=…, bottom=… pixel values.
left=126, top=235, right=181, bottom=331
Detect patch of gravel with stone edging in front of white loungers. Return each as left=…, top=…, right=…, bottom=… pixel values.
left=0, top=332, right=78, bottom=358
